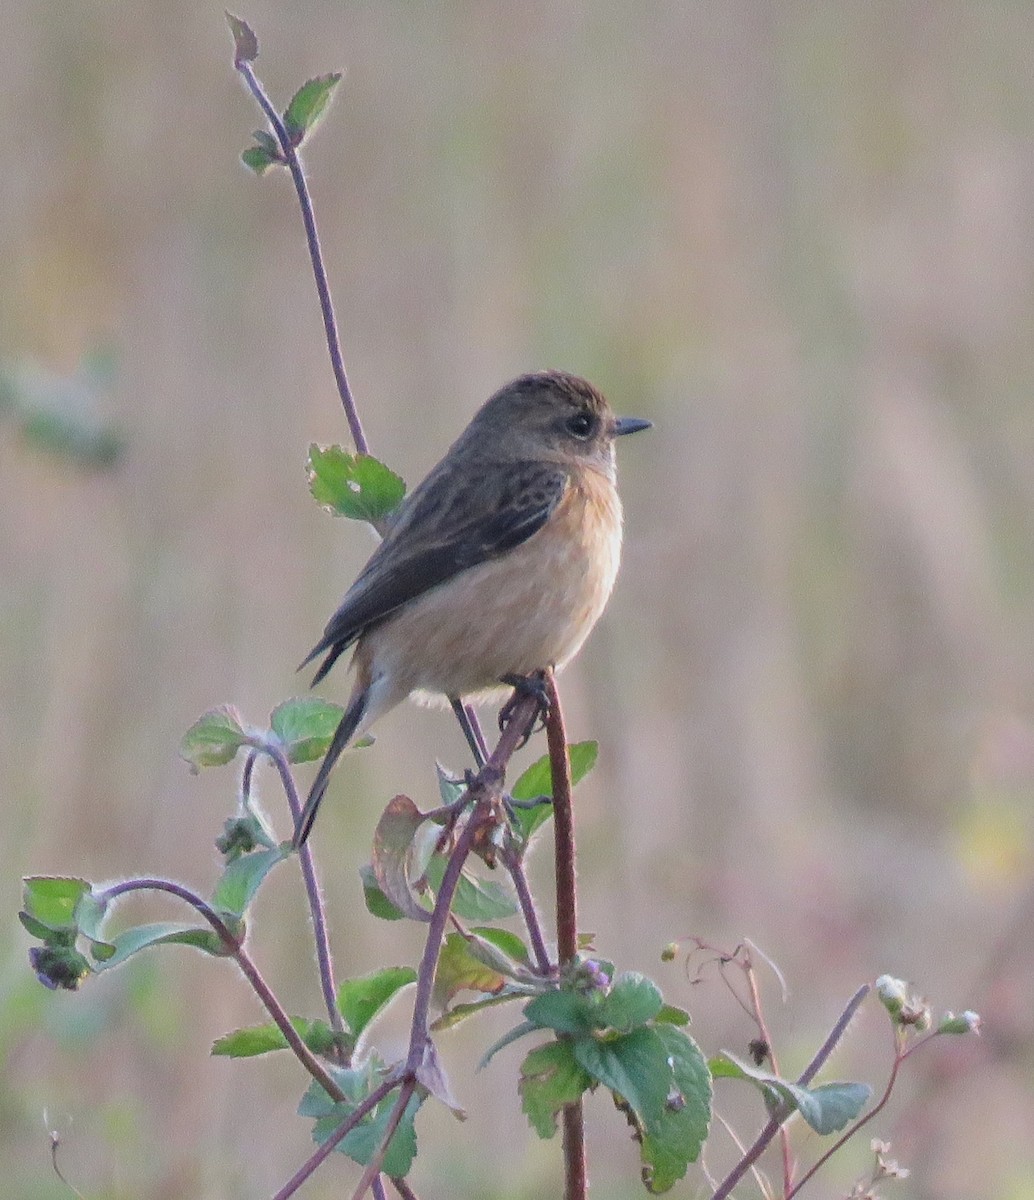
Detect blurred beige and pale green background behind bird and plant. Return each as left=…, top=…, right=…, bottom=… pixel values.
left=0, top=0, right=1034, bottom=1200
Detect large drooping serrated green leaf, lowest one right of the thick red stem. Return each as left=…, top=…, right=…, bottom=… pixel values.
left=642, top=1025, right=711, bottom=1193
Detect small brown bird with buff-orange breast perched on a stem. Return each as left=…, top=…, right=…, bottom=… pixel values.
left=294, top=371, right=650, bottom=846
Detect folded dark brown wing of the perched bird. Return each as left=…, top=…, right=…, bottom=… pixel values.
left=302, top=462, right=569, bottom=684
